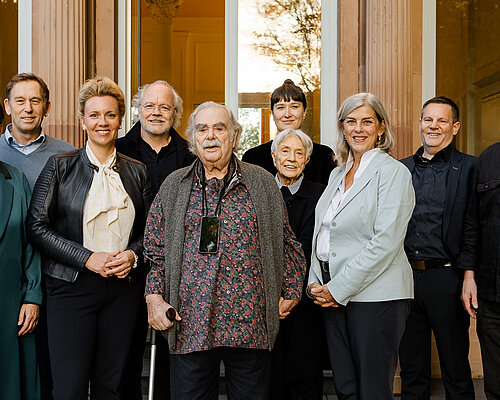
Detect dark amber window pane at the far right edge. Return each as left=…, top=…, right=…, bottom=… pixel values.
left=436, top=0, right=500, bottom=155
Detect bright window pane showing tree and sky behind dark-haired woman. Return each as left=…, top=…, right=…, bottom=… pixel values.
left=238, top=0, right=321, bottom=150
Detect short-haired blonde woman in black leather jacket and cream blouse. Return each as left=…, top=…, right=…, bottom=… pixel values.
left=27, top=77, right=153, bottom=400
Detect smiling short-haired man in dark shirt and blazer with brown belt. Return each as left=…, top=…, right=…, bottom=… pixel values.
left=399, top=97, right=476, bottom=400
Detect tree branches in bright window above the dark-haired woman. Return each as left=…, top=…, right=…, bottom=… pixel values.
left=253, top=0, right=321, bottom=92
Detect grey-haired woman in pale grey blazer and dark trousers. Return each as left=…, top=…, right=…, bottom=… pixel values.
left=308, top=93, right=415, bottom=400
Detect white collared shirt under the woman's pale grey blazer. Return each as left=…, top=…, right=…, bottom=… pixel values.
left=316, top=148, right=382, bottom=262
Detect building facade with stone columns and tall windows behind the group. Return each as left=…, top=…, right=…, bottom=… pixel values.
left=0, top=0, right=500, bottom=382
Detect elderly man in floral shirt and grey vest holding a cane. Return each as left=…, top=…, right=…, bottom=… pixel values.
left=144, top=102, right=306, bottom=400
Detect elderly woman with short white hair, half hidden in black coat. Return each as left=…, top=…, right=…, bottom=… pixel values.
left=270, top=128, right=325, bottom=400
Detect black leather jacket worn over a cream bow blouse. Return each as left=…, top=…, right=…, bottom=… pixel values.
left=26, top=147, right=154, bottom=282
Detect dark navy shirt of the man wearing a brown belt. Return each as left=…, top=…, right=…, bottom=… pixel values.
left=405, top=144, right=453, bottom=261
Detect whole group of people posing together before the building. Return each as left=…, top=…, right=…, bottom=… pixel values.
left=0, top=74, right=500, bottom=400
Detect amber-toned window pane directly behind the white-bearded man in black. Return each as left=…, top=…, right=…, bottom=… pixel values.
left=132, top=0, right=224, bottom=135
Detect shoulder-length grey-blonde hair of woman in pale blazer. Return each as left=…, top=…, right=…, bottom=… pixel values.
left=334, top=93, right=395, bottom=166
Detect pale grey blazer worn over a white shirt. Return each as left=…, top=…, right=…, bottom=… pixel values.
left=308, top=151, right=415, bottom=305
